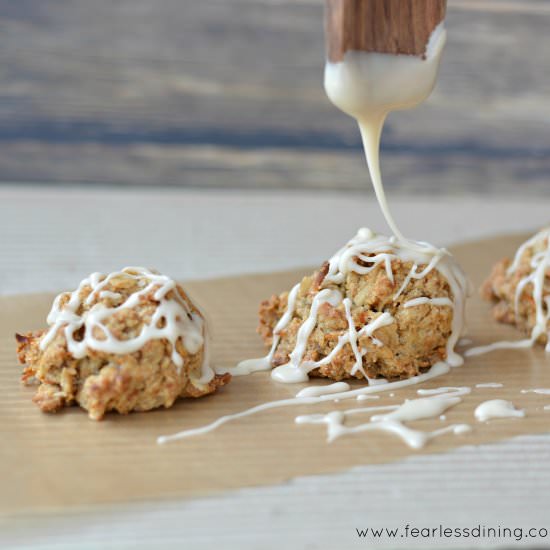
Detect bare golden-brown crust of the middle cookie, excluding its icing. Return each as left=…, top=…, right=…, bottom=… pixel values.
left=258, top=259, right=453, bottom=380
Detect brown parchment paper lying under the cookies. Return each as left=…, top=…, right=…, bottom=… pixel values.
left=0, top=236, right=550, bottom=514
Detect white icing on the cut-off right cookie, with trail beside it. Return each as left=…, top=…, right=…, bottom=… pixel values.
left=465, top=228, right=550, bottom=357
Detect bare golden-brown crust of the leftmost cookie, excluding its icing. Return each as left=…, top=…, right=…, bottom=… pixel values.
left=16, top=270, right=231, bottom=420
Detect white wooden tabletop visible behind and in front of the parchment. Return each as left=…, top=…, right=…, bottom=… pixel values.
left=0, top=185, right=550, bottom=549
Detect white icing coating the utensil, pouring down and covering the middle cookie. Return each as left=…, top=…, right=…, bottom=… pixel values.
left=233, top=23, right=468, bottom=383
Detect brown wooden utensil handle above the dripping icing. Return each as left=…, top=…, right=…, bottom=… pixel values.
left=325, top=0, right=447, bottom=63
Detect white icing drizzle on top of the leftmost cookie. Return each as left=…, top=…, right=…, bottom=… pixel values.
left=40, top=267, right=214, bottom=382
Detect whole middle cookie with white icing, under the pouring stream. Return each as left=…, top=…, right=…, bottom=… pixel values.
left=250, top=228, right=469, bottom=382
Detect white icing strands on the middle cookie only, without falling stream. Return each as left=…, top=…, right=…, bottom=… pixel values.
left=235, top=228, right=470, bottom=384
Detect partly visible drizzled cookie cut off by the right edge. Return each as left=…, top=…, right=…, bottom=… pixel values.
left=481, top=228, right=550, bottom=345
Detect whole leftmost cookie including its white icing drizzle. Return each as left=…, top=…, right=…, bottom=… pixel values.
left=16, top=267, right=230, bottom=420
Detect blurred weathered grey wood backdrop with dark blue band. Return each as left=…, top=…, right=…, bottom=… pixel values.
left=0, top=0, right=550, bottom=195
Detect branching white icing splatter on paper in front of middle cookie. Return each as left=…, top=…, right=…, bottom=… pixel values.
left=296, top=396, right=471, bottom=449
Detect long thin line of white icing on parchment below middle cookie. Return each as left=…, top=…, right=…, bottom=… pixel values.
left=157, top=362, right=450, bottom=444
